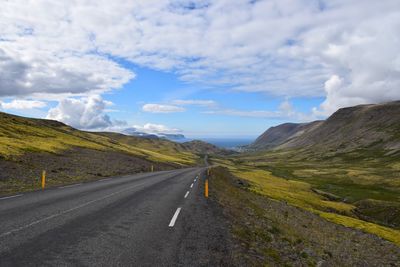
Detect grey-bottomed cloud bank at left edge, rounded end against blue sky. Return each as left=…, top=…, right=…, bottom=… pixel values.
left=0, top=47, right=134, bottom=99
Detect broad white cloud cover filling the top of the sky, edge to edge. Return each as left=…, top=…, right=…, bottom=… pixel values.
left=0, top=0, right=400, bottom=119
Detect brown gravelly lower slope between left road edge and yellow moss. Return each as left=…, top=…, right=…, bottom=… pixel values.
left=0, top=148, right=177, bottom=195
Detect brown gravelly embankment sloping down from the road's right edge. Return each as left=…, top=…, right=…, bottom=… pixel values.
left=210, top=167, right=400, bottom=266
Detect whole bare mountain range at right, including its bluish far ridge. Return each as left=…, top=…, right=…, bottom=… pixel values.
left=248, top=101, right=400, bottom=153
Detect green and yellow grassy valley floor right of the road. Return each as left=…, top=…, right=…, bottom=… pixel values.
left=209, top=155, right=400, bottom=245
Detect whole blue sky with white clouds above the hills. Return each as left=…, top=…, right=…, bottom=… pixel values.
left=0, top=0, right=400, bottom=138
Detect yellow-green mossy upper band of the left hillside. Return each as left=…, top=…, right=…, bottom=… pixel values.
left=0, top=113, right=197, bottom=165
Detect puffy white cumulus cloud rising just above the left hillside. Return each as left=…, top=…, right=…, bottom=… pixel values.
left=46, top=95, right=118, bottom=130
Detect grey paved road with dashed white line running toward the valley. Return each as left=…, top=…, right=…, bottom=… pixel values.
left=0, top=168, right=230, bottom=266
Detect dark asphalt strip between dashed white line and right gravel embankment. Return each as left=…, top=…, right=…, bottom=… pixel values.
left=177, top=172, right=235, bottom=266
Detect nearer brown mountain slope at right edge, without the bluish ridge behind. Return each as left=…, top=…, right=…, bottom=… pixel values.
left=279, top=101, right=400, bottom=152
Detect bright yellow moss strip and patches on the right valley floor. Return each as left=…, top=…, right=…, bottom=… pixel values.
left=213, top=158, right=400, bottom=245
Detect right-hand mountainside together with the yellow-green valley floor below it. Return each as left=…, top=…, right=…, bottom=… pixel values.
left=230, top=101, right=400, bottom=244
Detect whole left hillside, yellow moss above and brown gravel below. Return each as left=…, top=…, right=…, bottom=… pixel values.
left=0, top=113, right=201, bottom=194
